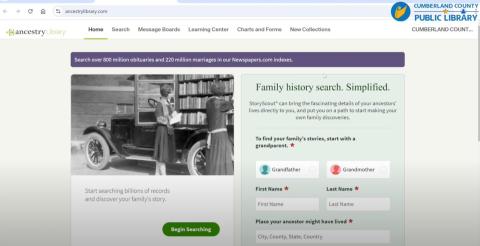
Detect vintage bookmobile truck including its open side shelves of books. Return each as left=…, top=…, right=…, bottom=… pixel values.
left=79, top=74, right=234, bottom=175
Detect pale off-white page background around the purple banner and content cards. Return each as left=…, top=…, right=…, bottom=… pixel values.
left=0, top=40, right=480, bottom=246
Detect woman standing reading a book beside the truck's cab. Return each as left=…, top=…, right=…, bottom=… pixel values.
left=153, top=85, right=176, bottom=175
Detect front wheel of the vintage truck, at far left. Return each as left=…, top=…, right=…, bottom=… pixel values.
left=85, top=133, right=110, bottom=170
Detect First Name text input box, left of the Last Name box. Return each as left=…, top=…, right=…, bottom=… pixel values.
left=256, top=198, right=320, bottom=211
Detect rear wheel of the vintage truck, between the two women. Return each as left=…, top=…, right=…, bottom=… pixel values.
left=187, top=140, right=207, bottom=175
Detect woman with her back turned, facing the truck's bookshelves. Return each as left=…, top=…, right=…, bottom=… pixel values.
left=206, top=82, right=233, bottom=175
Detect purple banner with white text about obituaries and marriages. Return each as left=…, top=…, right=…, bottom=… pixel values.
left=71, top=52, right=405, bottom=67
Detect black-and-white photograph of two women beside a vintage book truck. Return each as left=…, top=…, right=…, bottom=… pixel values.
left=71, top=74, right=234, bottom=175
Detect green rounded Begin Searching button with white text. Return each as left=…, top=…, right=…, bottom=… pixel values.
left=162, top=222, right=220, bottom=237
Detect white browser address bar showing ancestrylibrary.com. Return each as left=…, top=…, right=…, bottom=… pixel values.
left=55, top=4, right=390, bottom=18
